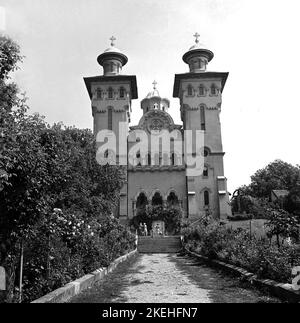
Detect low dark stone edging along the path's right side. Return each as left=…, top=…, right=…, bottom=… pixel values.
left=184, top=247, right=300, bottom=303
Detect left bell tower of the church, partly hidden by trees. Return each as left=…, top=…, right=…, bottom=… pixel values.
left=84, top=37, right=138, bottom=220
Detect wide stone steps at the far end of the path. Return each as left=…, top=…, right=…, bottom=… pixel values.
left=137, top=236, right=182, bottom=253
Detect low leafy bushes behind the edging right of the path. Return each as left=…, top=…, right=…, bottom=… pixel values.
left=183, top=223, right=300, bottom=283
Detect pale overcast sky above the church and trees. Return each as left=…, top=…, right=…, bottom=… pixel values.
left=0, top=0, right=300, bottom=192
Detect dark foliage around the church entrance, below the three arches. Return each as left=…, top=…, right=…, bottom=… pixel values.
left=131, top=205, right=183, bottom=234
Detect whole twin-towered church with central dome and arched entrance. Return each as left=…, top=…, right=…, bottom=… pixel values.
left=84, top=33, right=231, bottom=222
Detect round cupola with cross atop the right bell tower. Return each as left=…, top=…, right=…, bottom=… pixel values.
left=182, top=33, right=214, bottom=73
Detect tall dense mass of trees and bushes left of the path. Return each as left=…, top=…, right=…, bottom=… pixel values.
left=0, top=36, right=133, bottom=302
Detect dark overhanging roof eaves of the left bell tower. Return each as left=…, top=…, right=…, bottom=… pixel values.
left=83, top=75, right=138, bottom=99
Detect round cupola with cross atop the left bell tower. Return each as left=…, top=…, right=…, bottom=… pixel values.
left=97, top=36, right=128, bottom=76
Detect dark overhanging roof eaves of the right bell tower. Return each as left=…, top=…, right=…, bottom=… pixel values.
left=173, top=72, right=229, bottom=98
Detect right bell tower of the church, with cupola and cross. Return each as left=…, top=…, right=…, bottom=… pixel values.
left=173, top=33, right=231, bottom=219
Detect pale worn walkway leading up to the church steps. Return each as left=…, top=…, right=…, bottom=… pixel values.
left=71, top=254, right=279, bottom=303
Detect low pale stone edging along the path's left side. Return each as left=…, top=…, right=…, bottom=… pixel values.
left=31, top=249, right=137, bottom=303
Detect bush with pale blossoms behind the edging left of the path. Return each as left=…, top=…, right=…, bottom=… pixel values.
left=16, top=212, right=135, bottom=302
